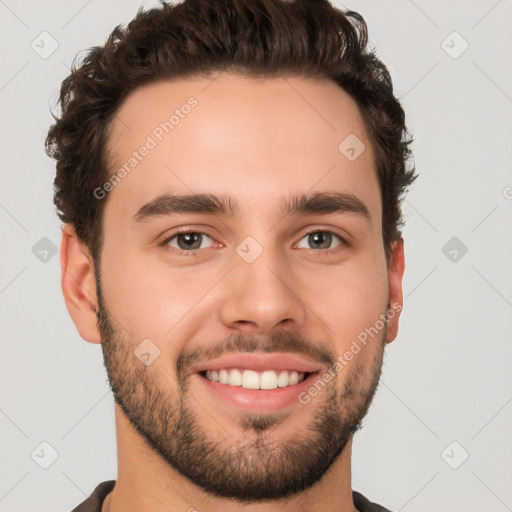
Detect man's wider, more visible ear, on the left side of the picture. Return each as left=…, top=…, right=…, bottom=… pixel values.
left=60, top=224, right=101, bottom=343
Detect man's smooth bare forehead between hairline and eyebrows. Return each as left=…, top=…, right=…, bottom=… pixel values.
left=106, top=73, right=380, bottom=219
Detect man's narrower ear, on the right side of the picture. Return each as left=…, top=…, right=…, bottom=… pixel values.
left=386, top=237, right=405, bottom=343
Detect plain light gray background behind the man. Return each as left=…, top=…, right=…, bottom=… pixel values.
left=0, top=0, right=512, bottom=512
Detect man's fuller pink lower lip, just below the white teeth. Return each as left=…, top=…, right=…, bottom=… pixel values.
left=194, top=372, right=318, bottom=412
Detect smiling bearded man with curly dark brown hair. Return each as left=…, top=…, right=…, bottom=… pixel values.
left=47, top=0, right=416, bottom=512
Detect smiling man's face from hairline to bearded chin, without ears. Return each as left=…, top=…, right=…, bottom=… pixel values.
left=97, top=74, right=400, bottom=501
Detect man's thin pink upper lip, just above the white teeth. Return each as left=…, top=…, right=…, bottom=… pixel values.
left=191, top=352, right=319, bottom=373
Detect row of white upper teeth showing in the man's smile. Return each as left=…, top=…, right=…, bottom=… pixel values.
left=206, top=368, right=304, bottom=389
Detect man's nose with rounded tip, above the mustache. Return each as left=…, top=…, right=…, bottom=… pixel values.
left=220, top=251, right=307, bottom=335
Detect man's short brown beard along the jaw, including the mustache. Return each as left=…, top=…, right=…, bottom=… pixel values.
left=96, top=267, right=386, bottom=503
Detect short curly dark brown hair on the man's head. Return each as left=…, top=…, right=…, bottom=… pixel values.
left=46, top=0, right=417, bottom=261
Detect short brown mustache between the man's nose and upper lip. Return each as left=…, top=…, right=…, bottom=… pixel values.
left=176, top=331, right=336, bottom=380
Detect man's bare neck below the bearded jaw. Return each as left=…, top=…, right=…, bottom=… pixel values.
left=107, top=405, right=357, bottom=512
